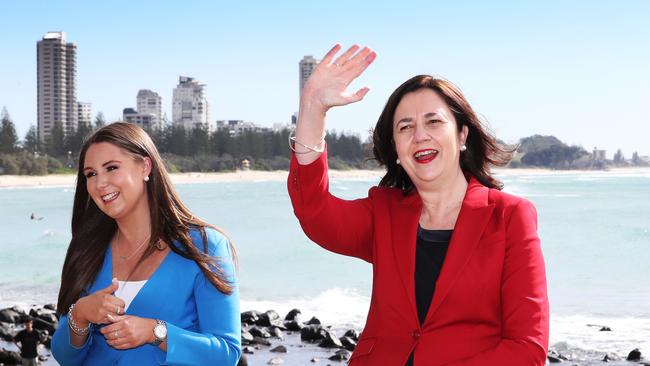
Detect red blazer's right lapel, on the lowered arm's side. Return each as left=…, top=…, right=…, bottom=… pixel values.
left=420, top=177, right=494, bottom=326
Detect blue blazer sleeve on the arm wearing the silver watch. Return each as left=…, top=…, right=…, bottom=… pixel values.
left=165, top=229, right=241, bottom=366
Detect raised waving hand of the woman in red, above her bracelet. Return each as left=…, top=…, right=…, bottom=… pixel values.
left=301, top=44, right=376, bottom=112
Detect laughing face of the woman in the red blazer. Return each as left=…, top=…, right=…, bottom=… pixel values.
left=393, top=88, right=467, bottom=189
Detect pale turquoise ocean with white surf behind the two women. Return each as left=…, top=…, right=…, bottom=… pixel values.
left=0, top=170, right=650, bottom=364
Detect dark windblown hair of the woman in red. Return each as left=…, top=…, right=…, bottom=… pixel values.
left=372, top=75, right=515, bottom=195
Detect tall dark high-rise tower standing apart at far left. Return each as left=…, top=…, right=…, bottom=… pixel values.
left=36, top=32, right=77, bottom=142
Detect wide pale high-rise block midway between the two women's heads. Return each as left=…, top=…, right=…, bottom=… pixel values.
left=172, top=76, right=210, bottom=130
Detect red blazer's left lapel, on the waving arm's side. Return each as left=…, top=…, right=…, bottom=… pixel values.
left=391, top=192, right=422, bottom=324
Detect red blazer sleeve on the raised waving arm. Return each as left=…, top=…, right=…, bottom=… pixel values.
left=288, top=150, right=373, bottom=262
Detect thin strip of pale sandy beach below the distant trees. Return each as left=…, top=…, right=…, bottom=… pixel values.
left=0, top=167, right=650, bottom=188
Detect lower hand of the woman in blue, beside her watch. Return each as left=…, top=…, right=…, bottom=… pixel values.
left=100, top=315, right=156, bottom=349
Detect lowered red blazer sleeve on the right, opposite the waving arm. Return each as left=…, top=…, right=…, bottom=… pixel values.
left=450, top=199, right=549, bottom=366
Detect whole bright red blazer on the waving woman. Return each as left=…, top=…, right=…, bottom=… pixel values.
left=288, top=153, right=549, bottom=366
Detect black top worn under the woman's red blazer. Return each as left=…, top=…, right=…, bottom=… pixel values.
left=406, top=225, right=454, bottom=366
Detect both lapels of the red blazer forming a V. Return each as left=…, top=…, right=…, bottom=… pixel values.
left=392, top=177, right=494, bottom=326
